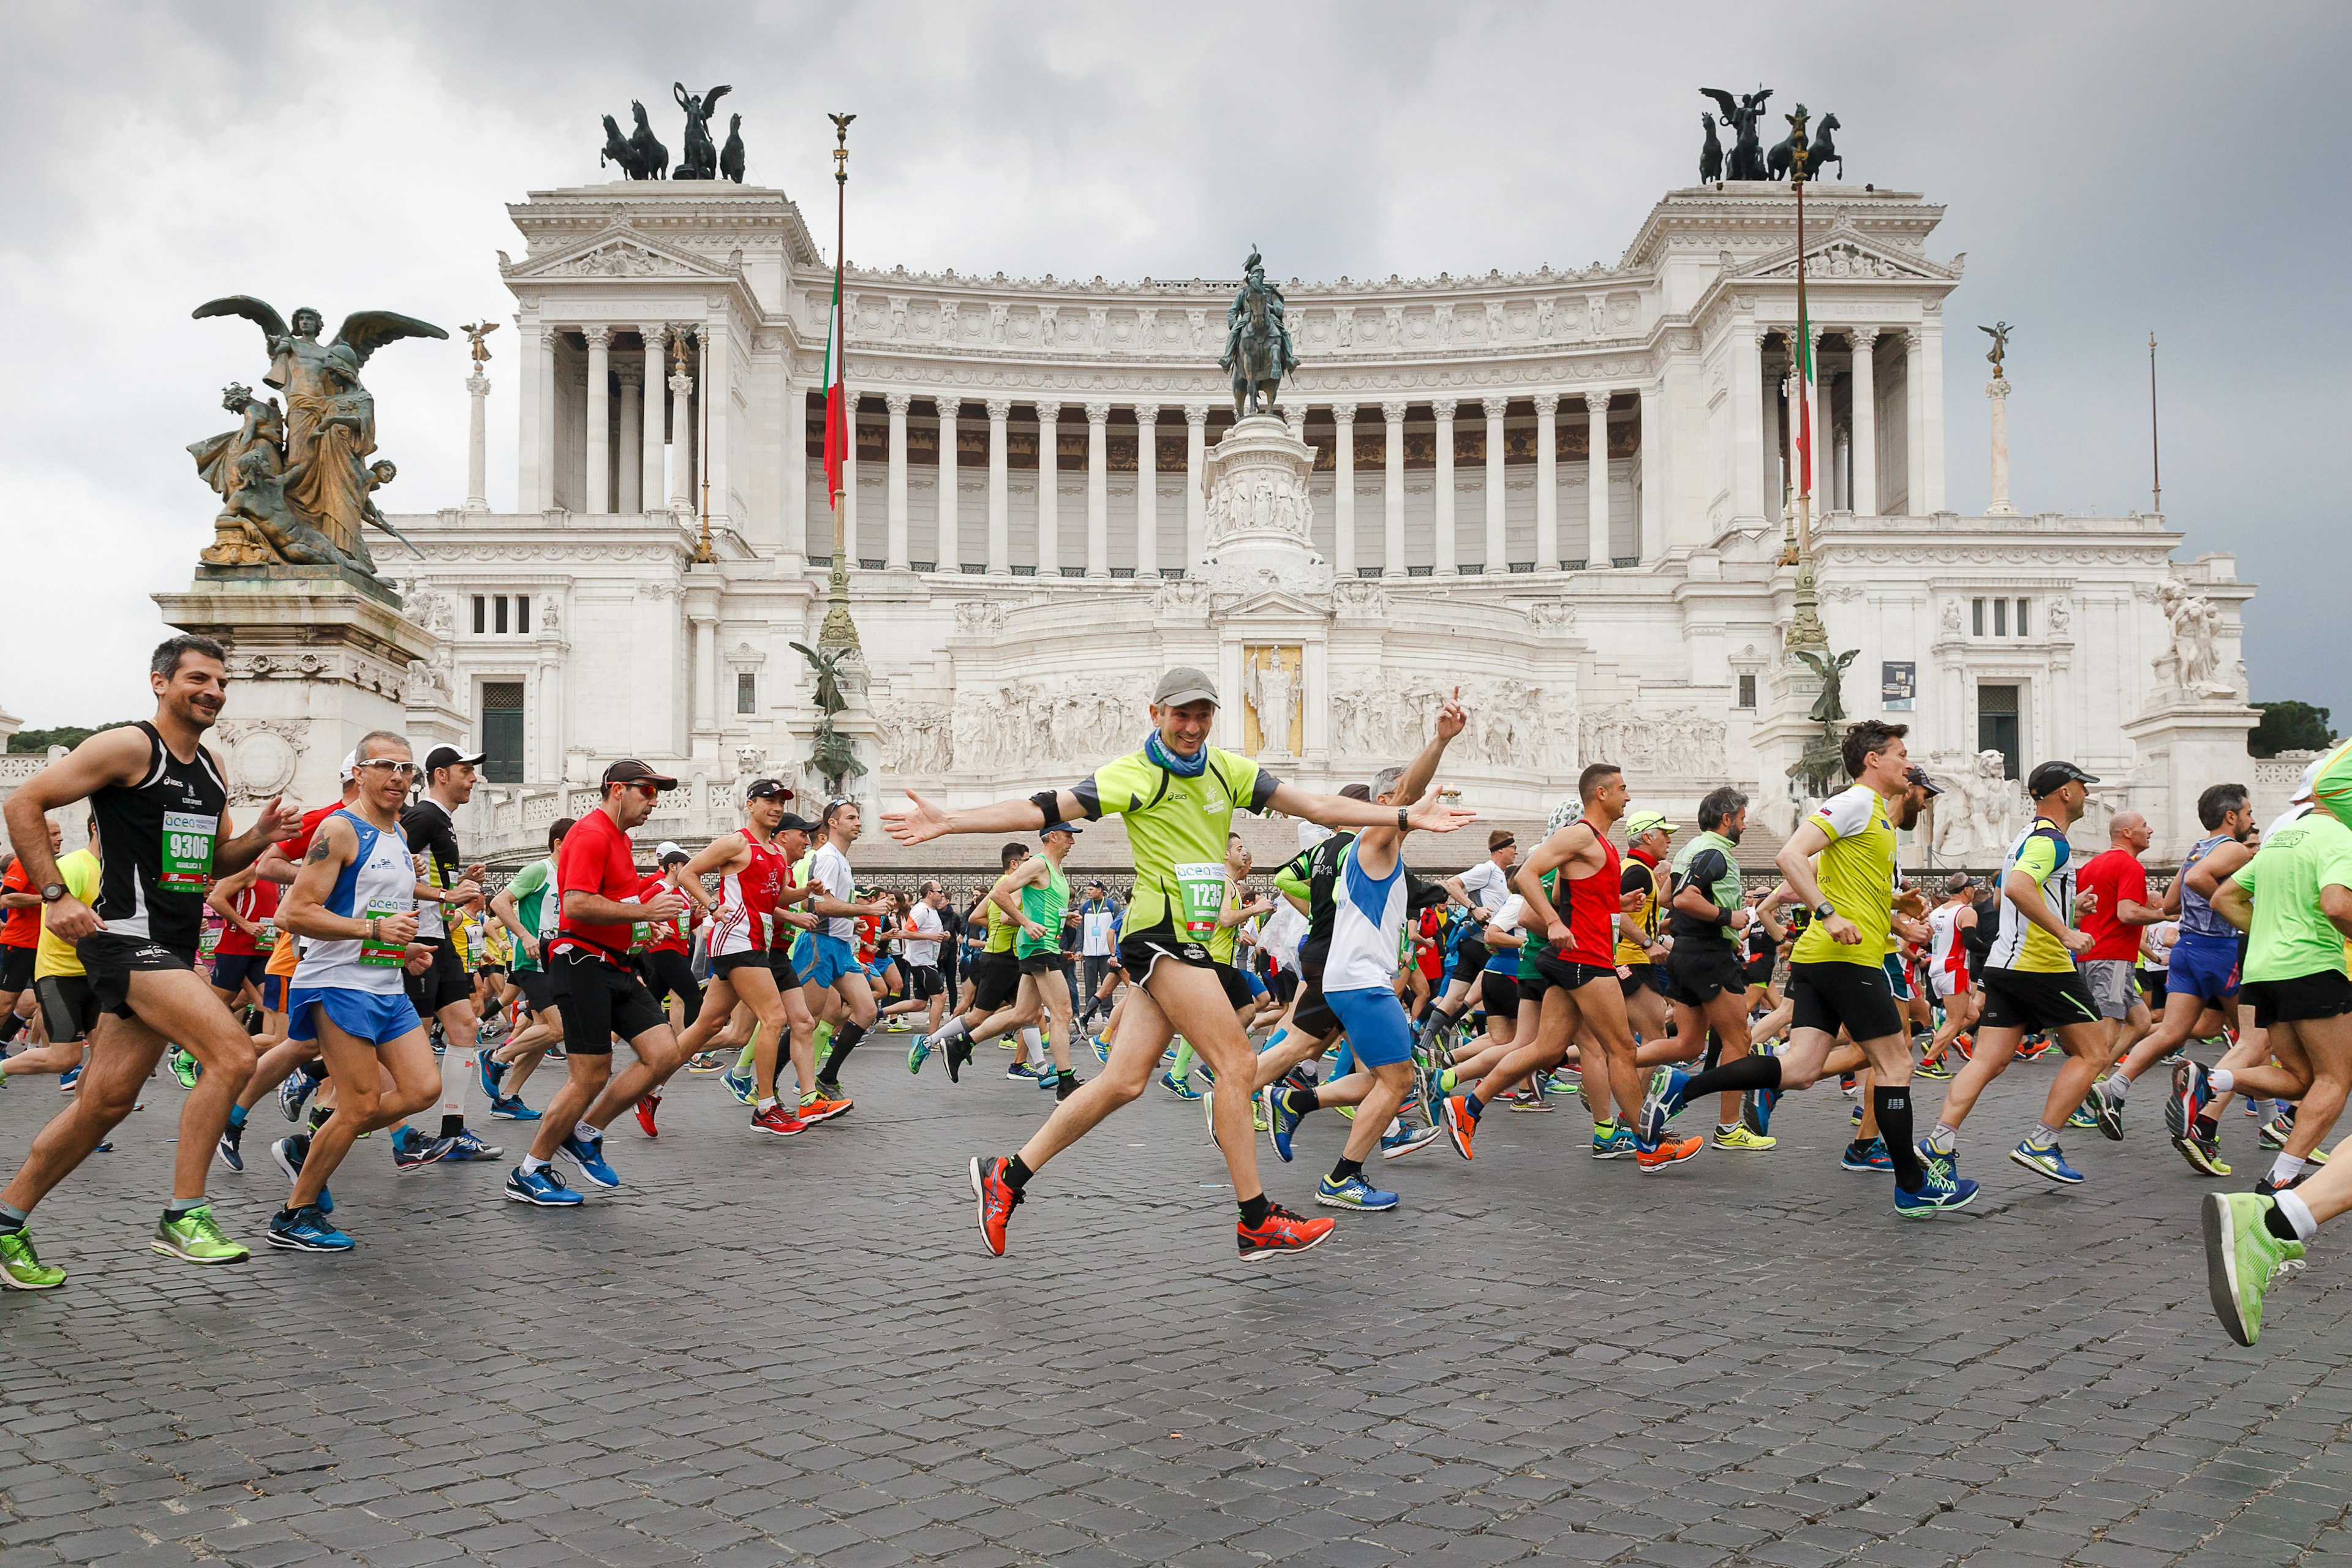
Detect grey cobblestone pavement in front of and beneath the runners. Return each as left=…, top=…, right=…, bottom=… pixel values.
left=0, top=1037, right=2352, bottom=1568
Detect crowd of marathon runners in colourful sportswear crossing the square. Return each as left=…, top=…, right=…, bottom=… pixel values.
left=0, top=637, right=2352, bottom=1344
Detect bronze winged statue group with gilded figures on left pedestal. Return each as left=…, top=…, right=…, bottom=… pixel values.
left=188, top=294, right=449, bottom=578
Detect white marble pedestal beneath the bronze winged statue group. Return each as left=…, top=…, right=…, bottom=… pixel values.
left=155, top=567, right=463, bottom=806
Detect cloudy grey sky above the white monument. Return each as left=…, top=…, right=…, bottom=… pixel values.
left=0, top=0, right=2352, bottom=729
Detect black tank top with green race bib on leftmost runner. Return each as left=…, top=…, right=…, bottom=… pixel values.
left=89, top=719, right=228, bottom=952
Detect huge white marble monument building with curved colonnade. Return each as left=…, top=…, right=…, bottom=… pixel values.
left=388, top=183, right=2253, bottom=879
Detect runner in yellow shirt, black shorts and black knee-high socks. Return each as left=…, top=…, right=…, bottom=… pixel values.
left=1642, top=719, right=1976, bottom=1220
